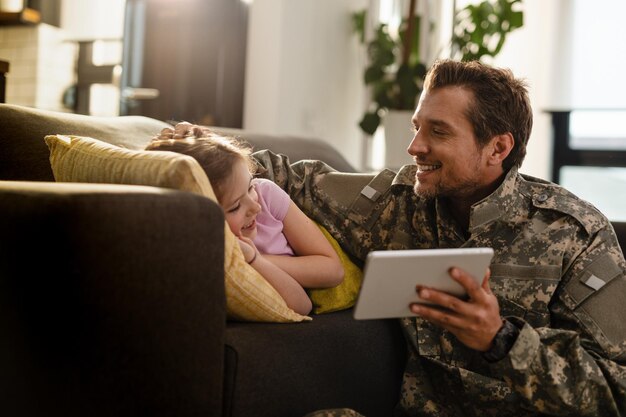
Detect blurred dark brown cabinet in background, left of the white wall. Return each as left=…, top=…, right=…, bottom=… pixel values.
left=120, top=0, right=248, bottom=127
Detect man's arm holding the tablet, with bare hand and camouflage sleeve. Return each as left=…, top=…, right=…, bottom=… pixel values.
left=412, top=221, right=626, bottom=416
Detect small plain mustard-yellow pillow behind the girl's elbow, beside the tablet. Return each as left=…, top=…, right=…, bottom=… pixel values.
left=308, top=224, right=363, bottom=314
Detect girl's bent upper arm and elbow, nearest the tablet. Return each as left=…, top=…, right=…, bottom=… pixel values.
left=265, top=201, right=344, bottom=288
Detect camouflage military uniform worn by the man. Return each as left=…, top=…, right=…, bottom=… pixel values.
left=255, top=151, right=626, bottom=417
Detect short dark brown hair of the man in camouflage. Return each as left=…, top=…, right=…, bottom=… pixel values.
left=424, top=59, right=533, bottom=171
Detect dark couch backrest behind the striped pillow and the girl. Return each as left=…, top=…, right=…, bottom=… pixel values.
left=0, top=104, right=356, bottom=181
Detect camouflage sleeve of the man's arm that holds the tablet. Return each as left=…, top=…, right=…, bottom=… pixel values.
left=491, top=223, right=626, bottom=416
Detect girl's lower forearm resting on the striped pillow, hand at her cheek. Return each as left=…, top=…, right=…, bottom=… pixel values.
left=239, top=236, right=313, bottom=315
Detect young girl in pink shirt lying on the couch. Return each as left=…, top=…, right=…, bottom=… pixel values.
left=146, top=125, right=344, bottom=315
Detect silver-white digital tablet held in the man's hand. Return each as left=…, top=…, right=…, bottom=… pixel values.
left=354, top=248, right=493, bottom=320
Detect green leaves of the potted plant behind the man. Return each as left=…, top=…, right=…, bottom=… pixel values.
left=352, top=0, right=523, bottom=135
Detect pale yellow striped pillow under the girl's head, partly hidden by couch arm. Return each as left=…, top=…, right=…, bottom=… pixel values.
left=45, top=135, right=311, bottom=322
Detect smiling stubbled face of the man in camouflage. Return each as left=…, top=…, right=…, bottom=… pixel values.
left=408, top=87, right=493, bottom=204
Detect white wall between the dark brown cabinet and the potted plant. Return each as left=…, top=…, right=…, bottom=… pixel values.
left=244, top=0, right=367, bottom=166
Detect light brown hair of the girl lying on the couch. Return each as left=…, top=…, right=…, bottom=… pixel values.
left=146, top=133, right=256, bottom=201
